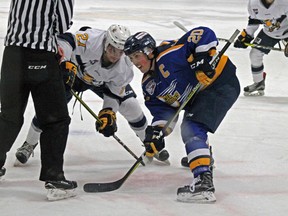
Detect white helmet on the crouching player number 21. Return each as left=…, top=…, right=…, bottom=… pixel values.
left=105, top=24, right=131, bottom=50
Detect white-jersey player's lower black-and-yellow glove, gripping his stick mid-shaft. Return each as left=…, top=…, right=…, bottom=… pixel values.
left=96, top=108, right=117, bottom=137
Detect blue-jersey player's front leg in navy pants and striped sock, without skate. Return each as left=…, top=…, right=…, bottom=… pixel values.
left=181, top=75, right=240, bottom=177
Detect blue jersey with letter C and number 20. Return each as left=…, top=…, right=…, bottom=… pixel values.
left=142, top=27, right=232, bottom=125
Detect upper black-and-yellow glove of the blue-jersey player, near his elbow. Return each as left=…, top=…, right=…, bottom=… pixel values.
left=191, top=52, right=215, bottom=86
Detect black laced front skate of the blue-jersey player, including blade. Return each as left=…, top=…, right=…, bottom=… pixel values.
left=177, top=171, right=216, bottom=203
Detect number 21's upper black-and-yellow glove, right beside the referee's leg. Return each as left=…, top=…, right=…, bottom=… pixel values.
left=60, top=61, right=77, bottom=88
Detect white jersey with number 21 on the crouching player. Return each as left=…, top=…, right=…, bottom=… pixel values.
left=58, top=29, right=134, bottom=97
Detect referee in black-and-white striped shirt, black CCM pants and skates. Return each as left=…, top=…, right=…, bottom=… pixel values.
left=0, top=0, right=77, bottom=200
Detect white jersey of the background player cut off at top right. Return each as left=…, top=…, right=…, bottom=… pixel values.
left=246, top=0, right=288, bottom=39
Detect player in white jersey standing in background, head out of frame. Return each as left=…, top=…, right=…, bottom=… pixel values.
left=234, top=0, right=288, bottom=96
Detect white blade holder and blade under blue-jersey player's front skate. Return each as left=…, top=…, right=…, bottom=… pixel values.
left=177, top=191, right=216, bottom=204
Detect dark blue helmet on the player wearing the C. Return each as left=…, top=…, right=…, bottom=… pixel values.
left=124, top=32, right=156, bottom=55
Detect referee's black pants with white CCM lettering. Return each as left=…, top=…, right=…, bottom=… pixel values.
left=0, top=46, right=70, bottom=181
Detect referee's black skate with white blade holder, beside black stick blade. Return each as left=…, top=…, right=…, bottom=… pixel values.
left=45, top=180, right=77, bottom=201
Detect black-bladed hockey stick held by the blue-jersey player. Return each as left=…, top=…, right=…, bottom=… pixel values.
left=83, top=29, right=240, bottom=193
